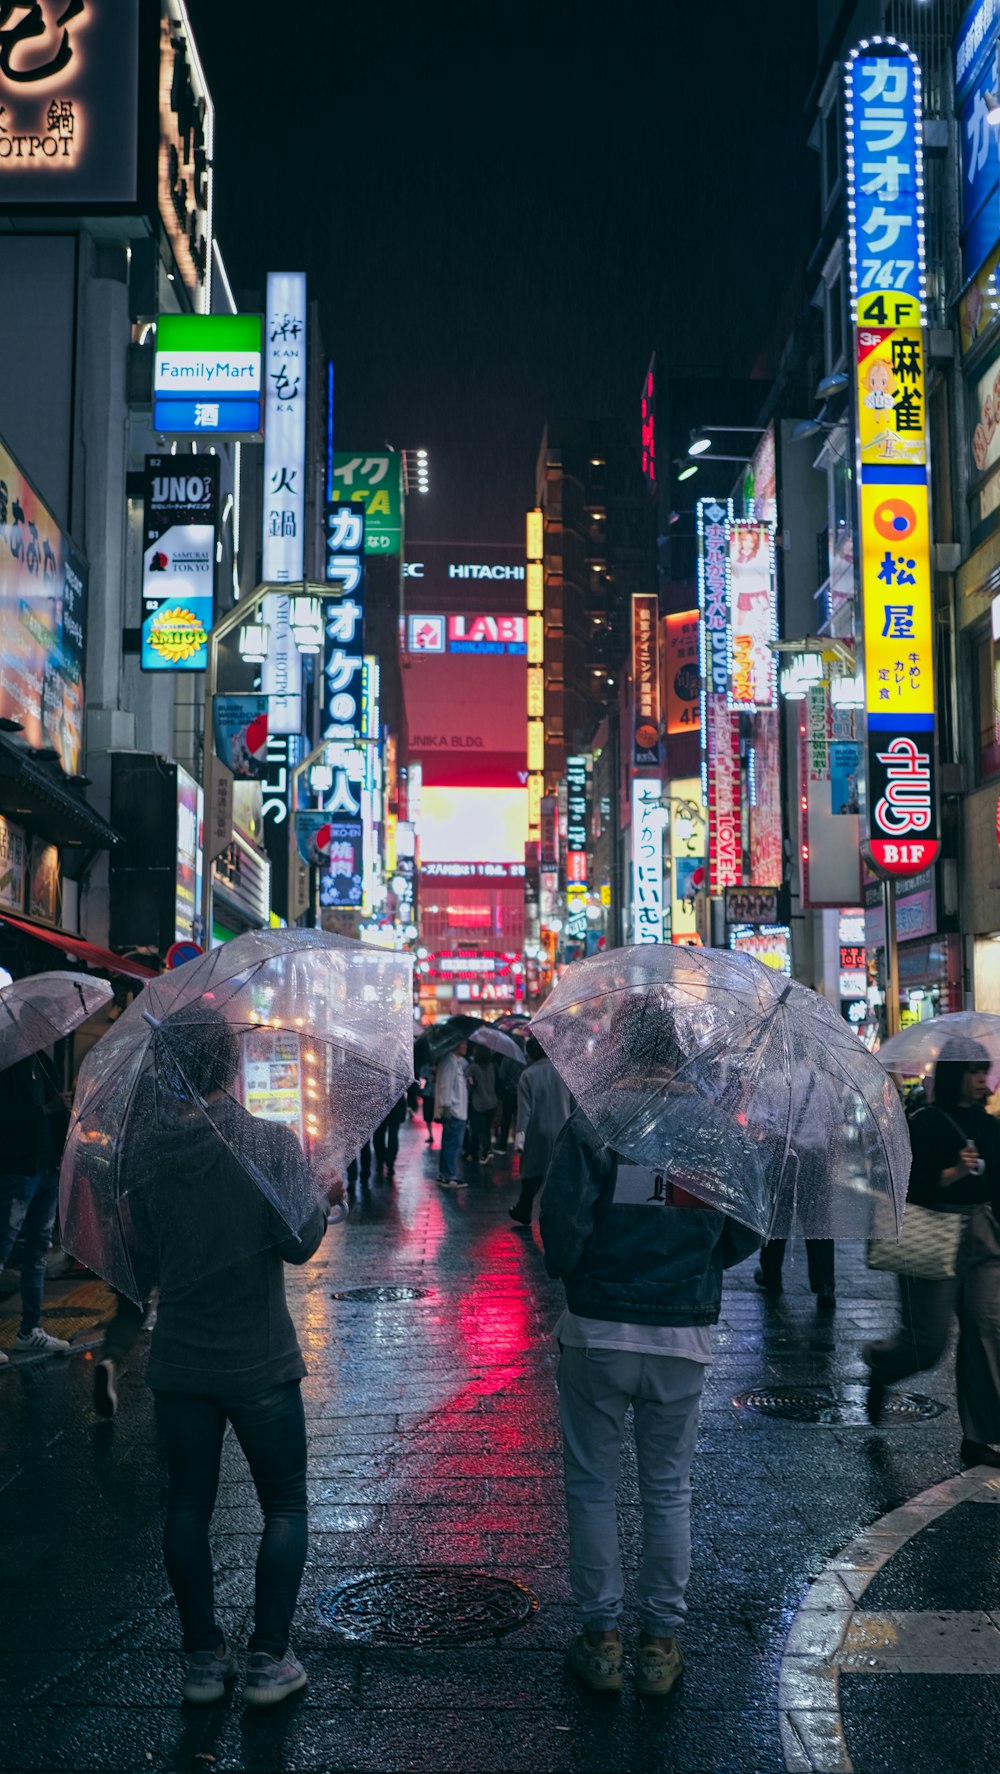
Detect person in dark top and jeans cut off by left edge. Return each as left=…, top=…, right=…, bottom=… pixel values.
left=0, top=1054, right=69, bottom=1364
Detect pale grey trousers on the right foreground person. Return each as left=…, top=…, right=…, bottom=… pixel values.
left=559, top=1348, right=706, bottom=1637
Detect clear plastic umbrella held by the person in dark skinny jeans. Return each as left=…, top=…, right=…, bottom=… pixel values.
left=60, top=930, right=413, bottom=1300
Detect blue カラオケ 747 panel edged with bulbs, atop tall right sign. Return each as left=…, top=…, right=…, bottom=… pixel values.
left=844, top=37, right=926, bottom=321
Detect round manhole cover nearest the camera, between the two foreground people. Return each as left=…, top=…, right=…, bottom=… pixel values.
left=316, top=1566, right=539, bottom=1644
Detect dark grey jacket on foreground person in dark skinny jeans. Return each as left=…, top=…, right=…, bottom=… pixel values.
left=128, top=1100, right=326, bottom=1398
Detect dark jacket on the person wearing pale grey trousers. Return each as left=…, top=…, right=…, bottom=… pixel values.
left=541, top=1109, right=761, bottom=1325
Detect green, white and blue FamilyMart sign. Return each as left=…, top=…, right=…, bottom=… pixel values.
left=152, top=314, right=262, bottom=438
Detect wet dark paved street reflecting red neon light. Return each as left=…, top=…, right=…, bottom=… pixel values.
left=0, top=1121, right=1000, bottom=1774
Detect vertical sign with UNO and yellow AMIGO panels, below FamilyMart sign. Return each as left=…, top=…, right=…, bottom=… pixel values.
left=140, top=456, right=218, bottom=671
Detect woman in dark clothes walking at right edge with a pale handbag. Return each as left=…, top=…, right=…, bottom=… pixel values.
left=863, top=1040, right=1000, bottom=1465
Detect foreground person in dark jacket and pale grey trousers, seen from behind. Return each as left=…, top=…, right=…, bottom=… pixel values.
left=541, top=1013, right=759, bottom=1694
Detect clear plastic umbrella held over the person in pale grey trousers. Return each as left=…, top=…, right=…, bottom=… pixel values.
left=532, top=944, right=910, bottom=1238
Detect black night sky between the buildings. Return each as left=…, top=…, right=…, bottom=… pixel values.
left=188, top=0, right=816, bottom=541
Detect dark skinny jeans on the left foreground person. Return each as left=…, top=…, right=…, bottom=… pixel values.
left=156, top=1380, right=309, bottom=1657
